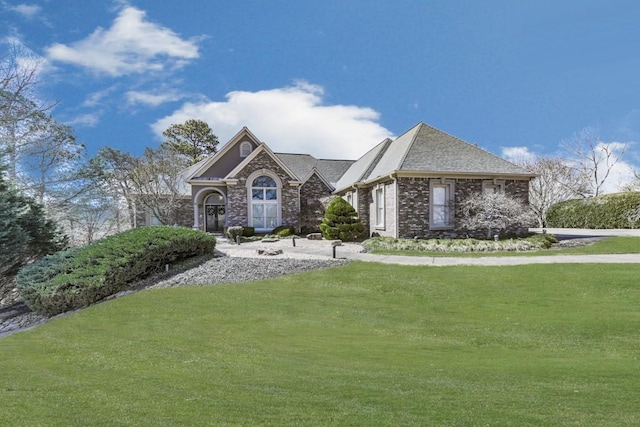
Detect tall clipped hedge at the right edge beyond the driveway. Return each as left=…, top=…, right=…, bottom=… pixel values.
left=547, top=192, right=640, bottom=229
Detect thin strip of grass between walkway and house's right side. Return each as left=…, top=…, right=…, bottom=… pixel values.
left=370, top=236, right=640, bottom=258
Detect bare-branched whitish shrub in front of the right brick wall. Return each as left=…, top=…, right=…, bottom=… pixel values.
left=459, top=192, right=535, bottom=239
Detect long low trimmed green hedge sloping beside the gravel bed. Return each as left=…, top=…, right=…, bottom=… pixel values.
left=16, top=226, right=216, bottom=316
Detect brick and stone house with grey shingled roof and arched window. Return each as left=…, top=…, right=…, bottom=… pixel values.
left=166, top=123, right=534, bottom=237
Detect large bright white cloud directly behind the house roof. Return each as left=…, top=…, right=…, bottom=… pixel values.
left=152, top=81, right=392, bottom=159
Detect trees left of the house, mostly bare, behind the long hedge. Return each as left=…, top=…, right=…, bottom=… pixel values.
left=0, top=44, right=218, bottom=290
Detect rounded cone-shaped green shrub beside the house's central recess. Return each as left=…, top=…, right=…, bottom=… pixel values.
left=320, top=197, right=364, bottom=242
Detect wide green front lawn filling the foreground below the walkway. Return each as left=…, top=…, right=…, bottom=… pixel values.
left=0, top=263, right=640, bottom=426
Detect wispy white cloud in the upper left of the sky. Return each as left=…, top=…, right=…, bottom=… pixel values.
left=46, top=6, right=199, bottom=76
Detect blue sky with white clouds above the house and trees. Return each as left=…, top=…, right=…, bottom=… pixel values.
left=0, top=0, right=640, bottom=188
